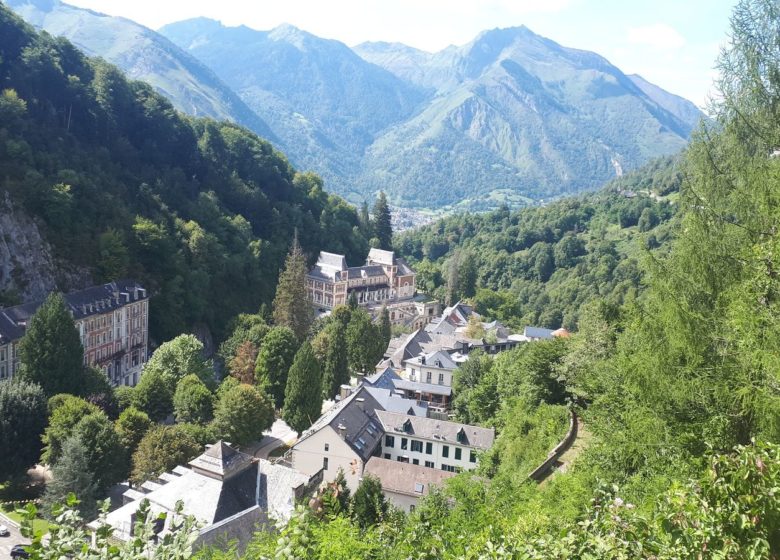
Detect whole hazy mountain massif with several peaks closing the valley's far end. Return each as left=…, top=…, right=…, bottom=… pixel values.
left=160, top=18, right=700, bottom=208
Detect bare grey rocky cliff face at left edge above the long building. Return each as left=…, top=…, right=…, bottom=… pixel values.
left=0, top=193, right=91, bottom=305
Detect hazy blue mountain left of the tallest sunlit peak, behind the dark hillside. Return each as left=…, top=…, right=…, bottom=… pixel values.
left=160, top=18, right=424, bottom=201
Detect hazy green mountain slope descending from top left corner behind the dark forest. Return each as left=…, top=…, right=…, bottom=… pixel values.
left=4, top=0, right=278, bottom=142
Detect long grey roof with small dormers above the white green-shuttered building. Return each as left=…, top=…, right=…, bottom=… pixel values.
left=377, top=411, right=496, bottom=450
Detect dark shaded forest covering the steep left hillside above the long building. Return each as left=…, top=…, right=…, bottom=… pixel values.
left=0, top=6, right=368, bottom=342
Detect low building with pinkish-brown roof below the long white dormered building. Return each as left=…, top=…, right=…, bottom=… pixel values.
left=364, top=457, right=455, bottom=513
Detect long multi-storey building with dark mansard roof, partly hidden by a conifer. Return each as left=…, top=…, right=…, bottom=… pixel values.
left=0, top=279, right=149, bottom=386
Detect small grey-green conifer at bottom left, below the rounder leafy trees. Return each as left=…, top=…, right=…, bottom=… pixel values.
left=43, top=437, right=96, bottom=519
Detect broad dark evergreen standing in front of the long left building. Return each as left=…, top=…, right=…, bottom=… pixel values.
left=19, top=293, right=87, bottom=396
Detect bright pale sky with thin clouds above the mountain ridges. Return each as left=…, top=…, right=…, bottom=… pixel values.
left=65, top=0, right=736, bottom=107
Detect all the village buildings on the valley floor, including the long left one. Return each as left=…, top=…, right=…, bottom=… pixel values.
left=0, top=249, right=569, bottom=545
